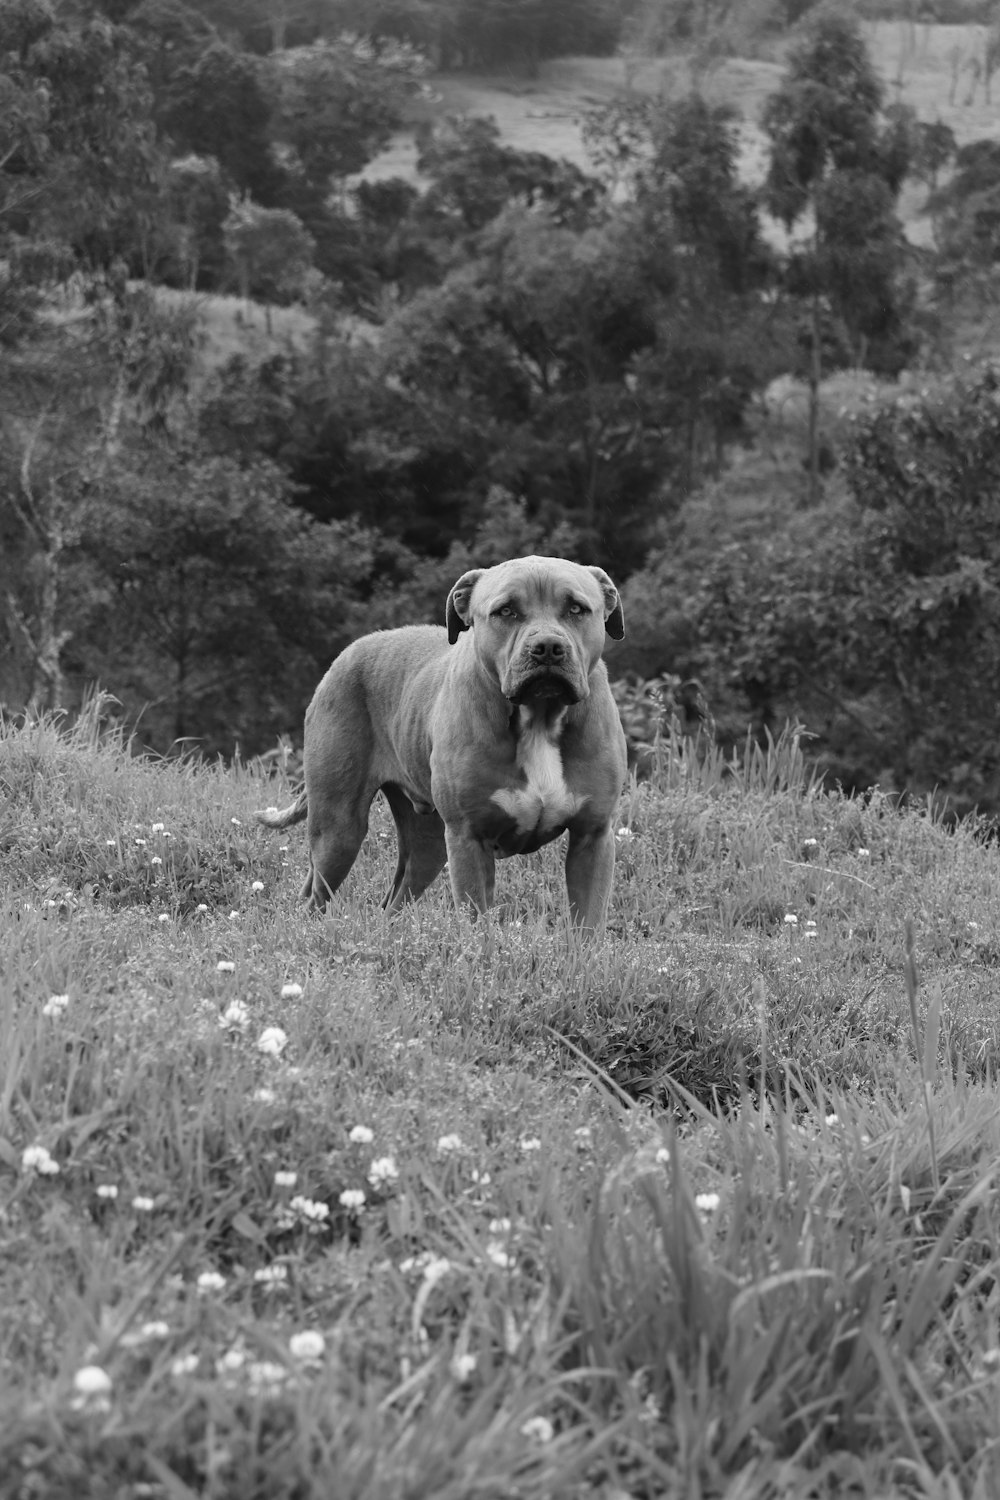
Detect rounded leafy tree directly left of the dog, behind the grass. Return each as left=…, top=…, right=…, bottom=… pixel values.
left=79, top=443, right=377, bottom=753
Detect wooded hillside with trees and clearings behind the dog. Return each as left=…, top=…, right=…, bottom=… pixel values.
left=0, top=0, right=1000, bottom=812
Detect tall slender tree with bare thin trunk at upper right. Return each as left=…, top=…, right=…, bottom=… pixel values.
left=763, top=11, right=909, bottom=503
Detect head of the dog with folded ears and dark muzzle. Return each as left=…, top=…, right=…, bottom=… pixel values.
left=447, top=557, right=625, bottom=704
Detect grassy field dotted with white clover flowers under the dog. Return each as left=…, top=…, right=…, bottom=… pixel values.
left=0, top=696, right=1000, bottom=1500
